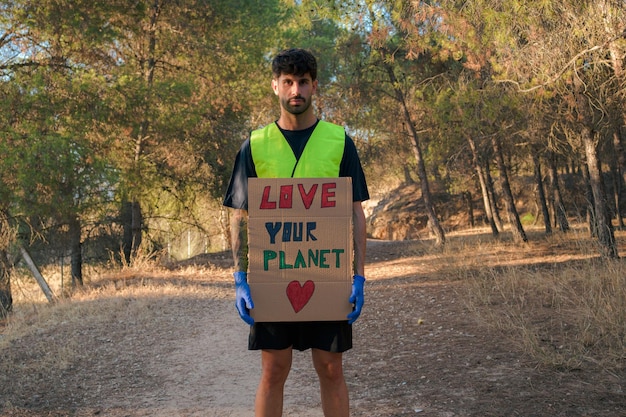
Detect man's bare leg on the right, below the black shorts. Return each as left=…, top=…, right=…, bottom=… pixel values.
left=312, top=349, right=350, bottom=417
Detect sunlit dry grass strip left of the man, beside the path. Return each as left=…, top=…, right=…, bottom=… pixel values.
left=0, top=252, right=231, bottom=356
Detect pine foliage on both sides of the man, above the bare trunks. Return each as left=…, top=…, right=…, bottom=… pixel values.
left=0, top=0, right=626, bottom=264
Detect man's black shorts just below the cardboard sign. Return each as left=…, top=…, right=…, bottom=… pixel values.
left=248, top=320, right=352, bottom=352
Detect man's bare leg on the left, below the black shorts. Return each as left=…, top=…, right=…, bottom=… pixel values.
left=254, top=348, right=292, bottom=417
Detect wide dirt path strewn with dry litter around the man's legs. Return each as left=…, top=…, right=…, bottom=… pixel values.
left=0, top=237, right=626, bottom=417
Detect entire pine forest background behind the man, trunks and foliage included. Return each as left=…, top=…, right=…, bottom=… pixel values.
left=0, top=0, right=626, bottom=315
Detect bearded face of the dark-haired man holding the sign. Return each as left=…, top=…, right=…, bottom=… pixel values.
left=272, top=73, right=317, bottom=115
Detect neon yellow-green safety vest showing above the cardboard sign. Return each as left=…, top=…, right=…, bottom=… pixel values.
left=250, top=120, right=346, bottom=178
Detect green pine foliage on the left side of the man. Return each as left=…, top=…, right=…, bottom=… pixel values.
left=0, top=0, right=298, bottom=260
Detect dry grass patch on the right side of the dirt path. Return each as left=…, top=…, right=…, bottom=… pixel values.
left=444, top=226, right=626, bottom=369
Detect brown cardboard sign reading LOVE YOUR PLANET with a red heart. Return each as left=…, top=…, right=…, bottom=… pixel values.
left=248, top=178, right=353, bottom=322
